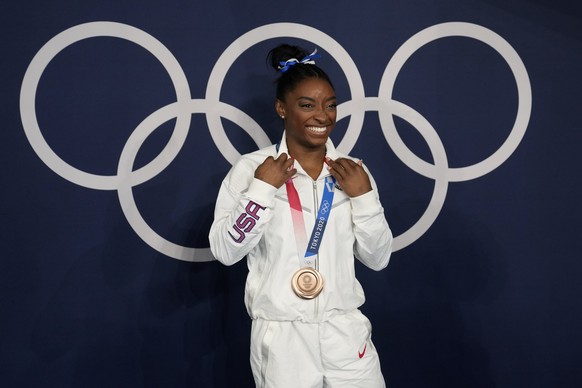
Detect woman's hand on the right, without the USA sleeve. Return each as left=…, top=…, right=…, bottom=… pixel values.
left=326, top=158, right=372, bottom=197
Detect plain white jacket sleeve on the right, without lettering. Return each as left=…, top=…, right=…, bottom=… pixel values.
left=351, top=165, right=394, bottom=271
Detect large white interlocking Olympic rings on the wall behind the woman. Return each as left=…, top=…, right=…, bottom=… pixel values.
left=20, top=22, right=532, bottom=262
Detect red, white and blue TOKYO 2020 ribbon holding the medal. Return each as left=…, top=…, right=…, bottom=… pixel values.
left=285, top=176, right=335, bottom=267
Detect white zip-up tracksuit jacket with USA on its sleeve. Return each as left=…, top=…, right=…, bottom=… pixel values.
left=209, top=133, right=393, bottom=322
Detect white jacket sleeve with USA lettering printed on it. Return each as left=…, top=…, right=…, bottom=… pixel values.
left=208, top=160, right=277, bottom=265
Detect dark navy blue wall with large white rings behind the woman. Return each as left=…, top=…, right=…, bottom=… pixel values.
left=0, top=0, right=582, bottom=387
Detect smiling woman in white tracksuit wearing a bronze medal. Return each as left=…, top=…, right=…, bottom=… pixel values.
left=209, top=45, right=392, bottom=388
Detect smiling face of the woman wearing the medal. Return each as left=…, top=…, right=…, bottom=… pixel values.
left=275, top=78, right=336, bottom=150
